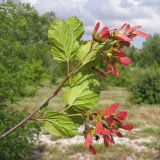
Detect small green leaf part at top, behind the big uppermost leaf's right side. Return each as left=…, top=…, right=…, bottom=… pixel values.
left=67, top=16, right=84, bottom=40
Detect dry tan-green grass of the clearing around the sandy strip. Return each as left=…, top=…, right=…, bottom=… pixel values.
left=10, top=82, right=160, bottom=160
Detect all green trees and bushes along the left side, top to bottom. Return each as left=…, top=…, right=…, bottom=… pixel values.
left=0, top=1, right=55, bottom=160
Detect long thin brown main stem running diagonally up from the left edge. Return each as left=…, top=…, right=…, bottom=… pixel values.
left=0, top=41, right=94, bottom=141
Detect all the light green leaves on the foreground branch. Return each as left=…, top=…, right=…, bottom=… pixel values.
left=45, top=17, right=101, bottom=136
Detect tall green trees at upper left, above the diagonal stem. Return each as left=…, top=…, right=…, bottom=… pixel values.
left=0, top=1, right=57, bottom=103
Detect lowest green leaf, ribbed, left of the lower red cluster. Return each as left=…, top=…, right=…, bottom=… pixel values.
left=44, top=112, right=77, bottom=137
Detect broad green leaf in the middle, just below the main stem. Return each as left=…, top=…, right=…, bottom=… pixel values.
left=63, top=73, right=99, bottom=113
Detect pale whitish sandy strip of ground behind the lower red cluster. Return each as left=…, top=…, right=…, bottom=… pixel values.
left=40, top=126, right=154, bottom=152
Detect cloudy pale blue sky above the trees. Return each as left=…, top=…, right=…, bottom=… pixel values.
left=1, top=0, right=160, bottom=47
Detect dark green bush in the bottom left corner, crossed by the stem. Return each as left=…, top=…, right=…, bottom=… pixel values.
left=0, top=108, right=40, bottom=160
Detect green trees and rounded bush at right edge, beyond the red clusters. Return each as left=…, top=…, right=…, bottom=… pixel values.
left=124, top=34, right=160, bottom=104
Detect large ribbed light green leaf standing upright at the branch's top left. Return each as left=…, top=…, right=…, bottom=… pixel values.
left=48, top=20, right=79, bottom=62
